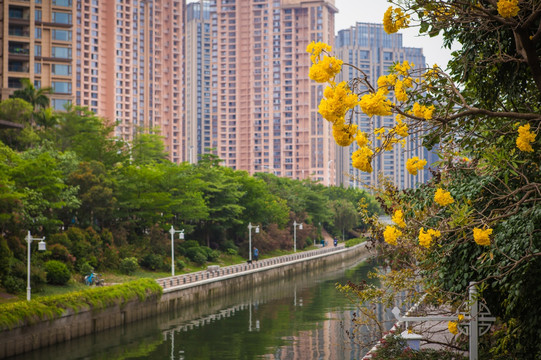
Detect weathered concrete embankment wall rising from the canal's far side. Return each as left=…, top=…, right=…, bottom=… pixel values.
left=0, top=244, right=367, bottom=359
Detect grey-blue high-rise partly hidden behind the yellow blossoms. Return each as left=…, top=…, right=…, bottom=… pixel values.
left=334, top=23, right=433, bottom=189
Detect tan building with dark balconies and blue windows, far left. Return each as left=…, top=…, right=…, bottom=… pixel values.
left=0, top=0, right=76, bottom=110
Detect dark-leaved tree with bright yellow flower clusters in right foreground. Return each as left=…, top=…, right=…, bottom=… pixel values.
left=312, top=0, right=541, bottom=359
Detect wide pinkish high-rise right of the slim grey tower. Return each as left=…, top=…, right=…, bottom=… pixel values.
left=211, top=0, right=337, bottom=184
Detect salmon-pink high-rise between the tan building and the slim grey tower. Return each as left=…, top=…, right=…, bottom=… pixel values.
left=76, top=0, right=186, bottom=162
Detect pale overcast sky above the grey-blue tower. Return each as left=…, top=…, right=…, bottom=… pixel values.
left=335, top=0, right=451, bottom=68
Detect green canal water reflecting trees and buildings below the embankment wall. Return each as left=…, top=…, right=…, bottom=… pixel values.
left=11, top=262, right=388, bottom=360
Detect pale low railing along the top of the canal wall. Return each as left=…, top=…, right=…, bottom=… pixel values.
left=156, top=245, right=354, bottom=289
